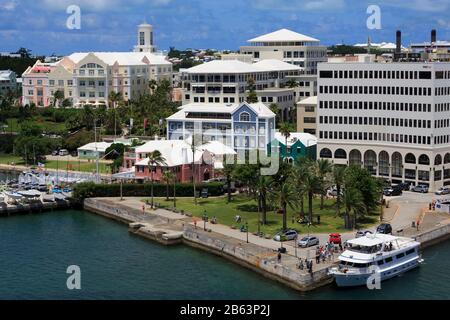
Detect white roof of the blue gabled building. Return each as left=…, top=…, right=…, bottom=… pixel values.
left=167, top=102, right=275, bottom=121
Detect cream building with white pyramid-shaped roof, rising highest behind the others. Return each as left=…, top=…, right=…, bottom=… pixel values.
left=240, top=29, right=327, bottom=74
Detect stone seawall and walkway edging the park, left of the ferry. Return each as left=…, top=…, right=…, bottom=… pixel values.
left=84, top=199, right=332, bottom=291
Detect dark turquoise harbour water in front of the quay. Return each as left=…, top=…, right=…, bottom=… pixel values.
left=0, top=211, right=450, bottom=299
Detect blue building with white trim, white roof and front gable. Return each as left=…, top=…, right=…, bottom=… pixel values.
left=167, top=102, right=275, bottom=151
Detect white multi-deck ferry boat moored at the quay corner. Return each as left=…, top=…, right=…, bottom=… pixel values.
left=329, top=234, right=423, bottom=287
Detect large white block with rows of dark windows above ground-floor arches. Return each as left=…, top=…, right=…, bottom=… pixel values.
left=317, top=63, right=450, bottom=191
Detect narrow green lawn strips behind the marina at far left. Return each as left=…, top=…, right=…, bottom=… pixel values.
left=0, top=154, right=111, bottom=174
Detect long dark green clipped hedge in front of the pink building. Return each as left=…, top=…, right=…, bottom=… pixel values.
left=72, top=182, right=225, bottom=202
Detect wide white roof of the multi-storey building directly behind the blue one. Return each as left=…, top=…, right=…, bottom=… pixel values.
left=186, top=59, right=302, bottom=74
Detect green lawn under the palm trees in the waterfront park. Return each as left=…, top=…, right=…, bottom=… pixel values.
left=147, top=196, right=379, bottom=235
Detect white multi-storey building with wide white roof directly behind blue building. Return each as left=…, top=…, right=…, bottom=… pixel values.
left=182, top=60, right=302, bottom=119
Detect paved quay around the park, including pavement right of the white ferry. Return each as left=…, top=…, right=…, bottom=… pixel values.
left=85, top=197, right=450, bottom=291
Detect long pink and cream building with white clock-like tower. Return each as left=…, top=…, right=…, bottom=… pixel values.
left=22, top=24, right=172, bottom=107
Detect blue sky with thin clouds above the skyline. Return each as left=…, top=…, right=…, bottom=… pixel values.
left=0, top=0, right=450, bottom=55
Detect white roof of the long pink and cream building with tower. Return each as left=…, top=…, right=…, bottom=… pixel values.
left=68, top=52, right=172, bottom=66
